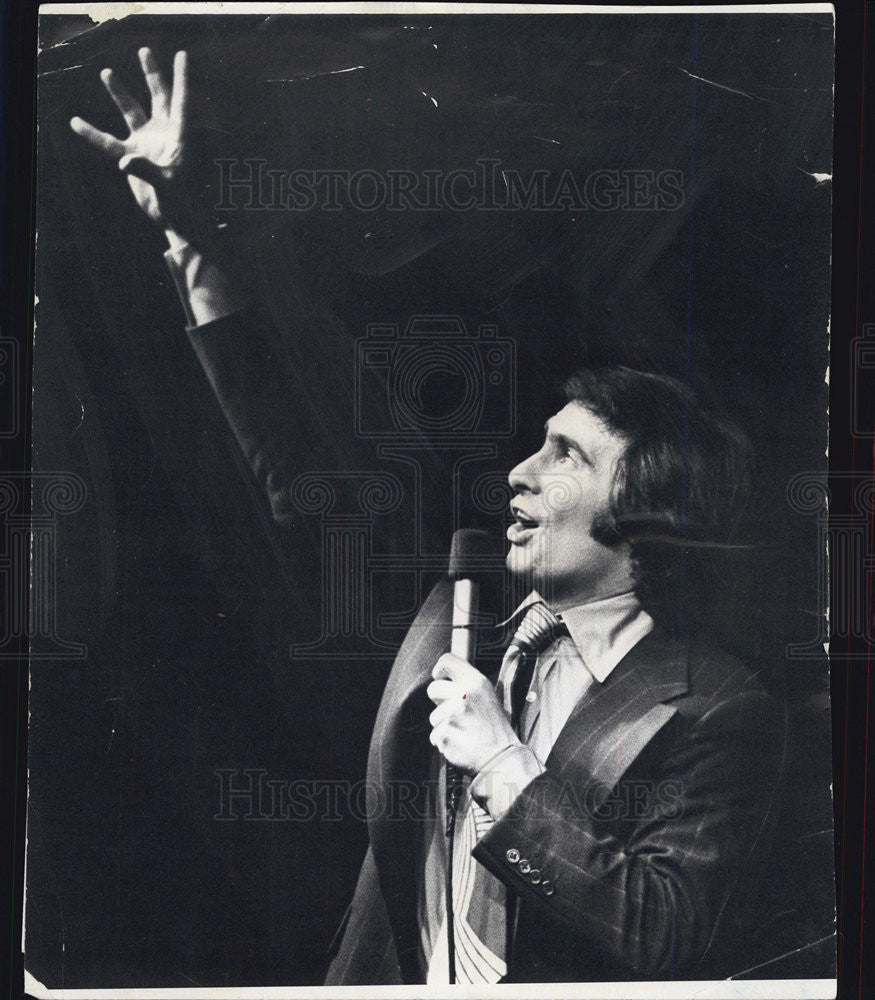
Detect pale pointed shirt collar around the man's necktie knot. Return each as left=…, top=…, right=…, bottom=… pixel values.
left=512, top=590, right=654, bottom=683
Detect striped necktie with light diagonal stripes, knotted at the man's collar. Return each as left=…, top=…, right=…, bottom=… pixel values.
left=428, top=602, right=568, bottom=984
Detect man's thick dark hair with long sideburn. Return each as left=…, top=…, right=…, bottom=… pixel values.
left=565, top=367, right=753, bottom=622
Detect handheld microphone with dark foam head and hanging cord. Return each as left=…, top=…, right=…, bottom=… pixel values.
left=446, top=528, right=492, bottom=983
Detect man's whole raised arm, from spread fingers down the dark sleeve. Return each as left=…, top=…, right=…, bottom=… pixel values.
left=70, top=48, right=319, bottom=520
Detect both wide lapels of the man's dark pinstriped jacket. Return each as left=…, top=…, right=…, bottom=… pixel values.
left=368, top=580, right=688, bottom=982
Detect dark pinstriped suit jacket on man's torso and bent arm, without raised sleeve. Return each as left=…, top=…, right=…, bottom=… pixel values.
left=327, top=585, right=785, bottom=985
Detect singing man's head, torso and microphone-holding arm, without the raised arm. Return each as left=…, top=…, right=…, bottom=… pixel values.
left=328, top=368, right=784, bottom=984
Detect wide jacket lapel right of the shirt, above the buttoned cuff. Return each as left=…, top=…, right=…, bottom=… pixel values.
left=547, top=629, right=688, bottom=809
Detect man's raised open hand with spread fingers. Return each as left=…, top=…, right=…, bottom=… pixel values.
left=70, top=48, right=191, bottom=234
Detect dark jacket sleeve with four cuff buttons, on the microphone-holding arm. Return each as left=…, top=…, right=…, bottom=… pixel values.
left=474, top=688, right=783, bottom=977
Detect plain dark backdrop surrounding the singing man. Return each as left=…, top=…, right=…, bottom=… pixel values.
left=0, top=7, right=842, bottom=987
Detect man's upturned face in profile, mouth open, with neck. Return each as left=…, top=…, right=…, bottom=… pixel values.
left=507, top=403, right=632, bottom=610
